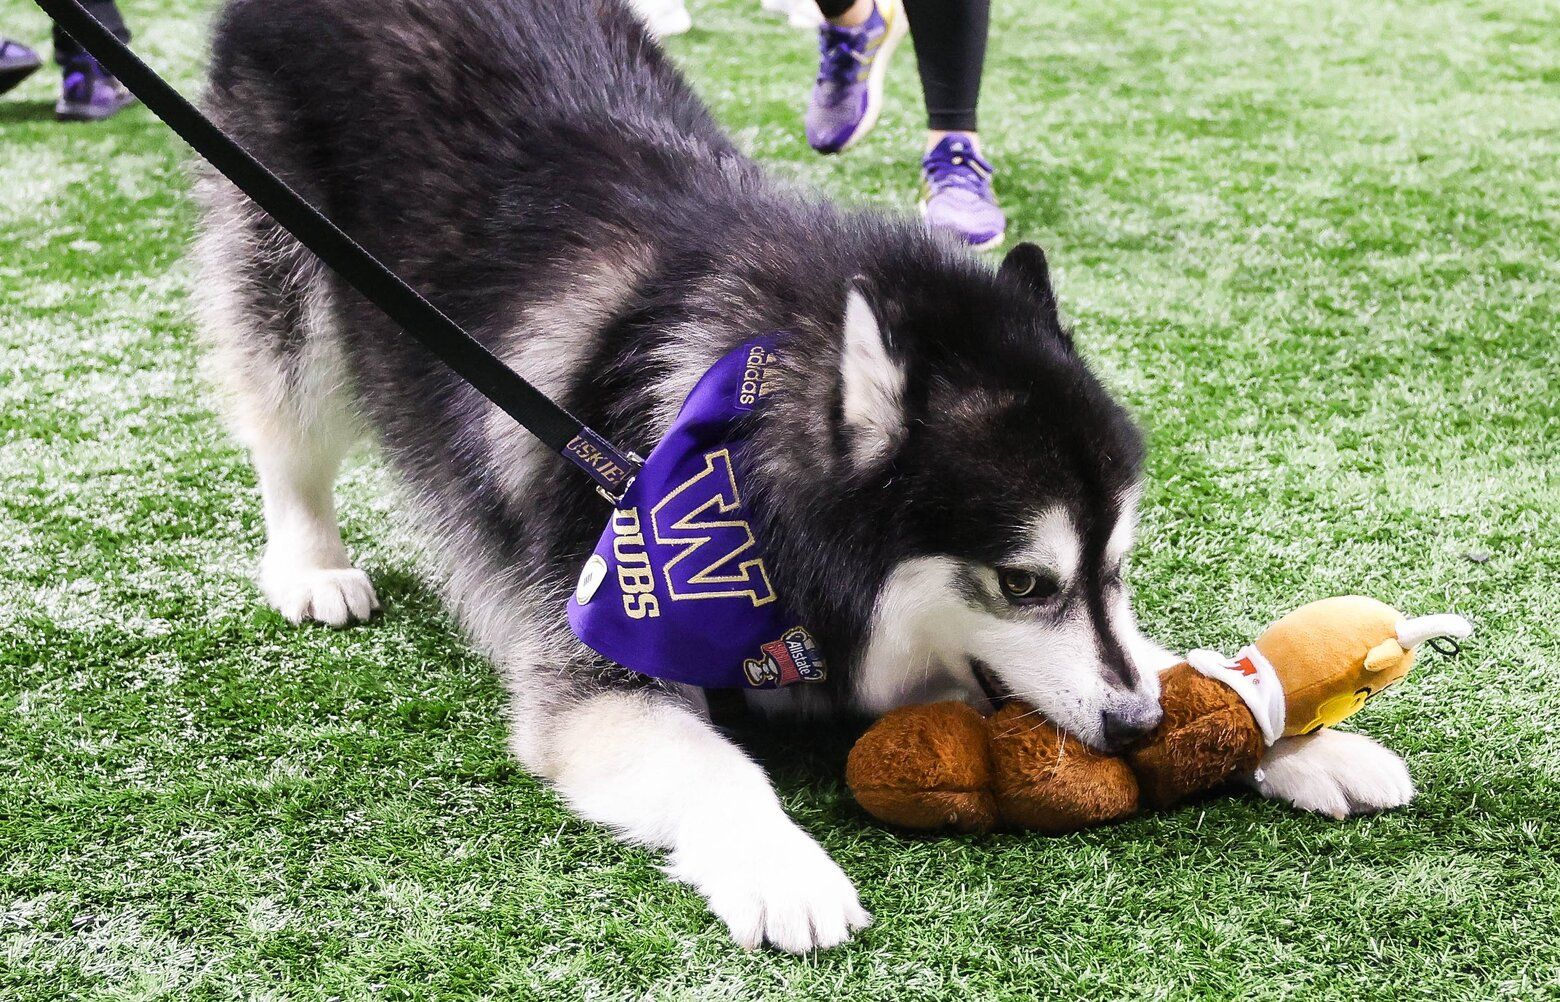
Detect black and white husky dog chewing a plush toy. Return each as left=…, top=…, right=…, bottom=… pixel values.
left=198, top=0, right=1412, bottom=950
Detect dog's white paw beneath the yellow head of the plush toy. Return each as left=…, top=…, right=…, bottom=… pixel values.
left=1253, top=729, right=1413, bottom=818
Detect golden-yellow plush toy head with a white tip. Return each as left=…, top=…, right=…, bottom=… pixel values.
left=1256, top=595, right=1473, bottom=735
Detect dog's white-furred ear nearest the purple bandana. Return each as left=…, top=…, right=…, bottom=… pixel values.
left=839, top=278, right=905, bottom=465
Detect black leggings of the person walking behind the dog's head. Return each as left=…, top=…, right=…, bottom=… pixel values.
left=817, top=0, right=991, bottom=133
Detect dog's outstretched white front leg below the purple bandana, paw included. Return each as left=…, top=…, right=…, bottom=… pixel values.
left=526, top=690, right=872, bottom=952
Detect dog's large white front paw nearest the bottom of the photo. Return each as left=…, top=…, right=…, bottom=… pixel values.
left=666, top=821, right=872, bottom=954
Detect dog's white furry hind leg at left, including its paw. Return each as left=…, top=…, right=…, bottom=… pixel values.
left=197, top=179, right=379, bottom=626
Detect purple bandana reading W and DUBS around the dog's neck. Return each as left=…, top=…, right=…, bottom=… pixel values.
left=569, top=337, right=824, bottom=688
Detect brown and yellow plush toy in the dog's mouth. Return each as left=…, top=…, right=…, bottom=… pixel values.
left=846, top=596, right=1473, bottom=833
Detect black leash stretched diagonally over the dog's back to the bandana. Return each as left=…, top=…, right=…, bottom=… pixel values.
left=34, top=0, right=640, bottom=504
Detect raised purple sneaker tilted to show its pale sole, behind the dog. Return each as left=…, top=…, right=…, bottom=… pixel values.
left=807, top=0, right=908, bottom=153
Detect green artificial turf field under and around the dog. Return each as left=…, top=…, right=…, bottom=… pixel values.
left=0, top=0, right=1560, bottom=1002
